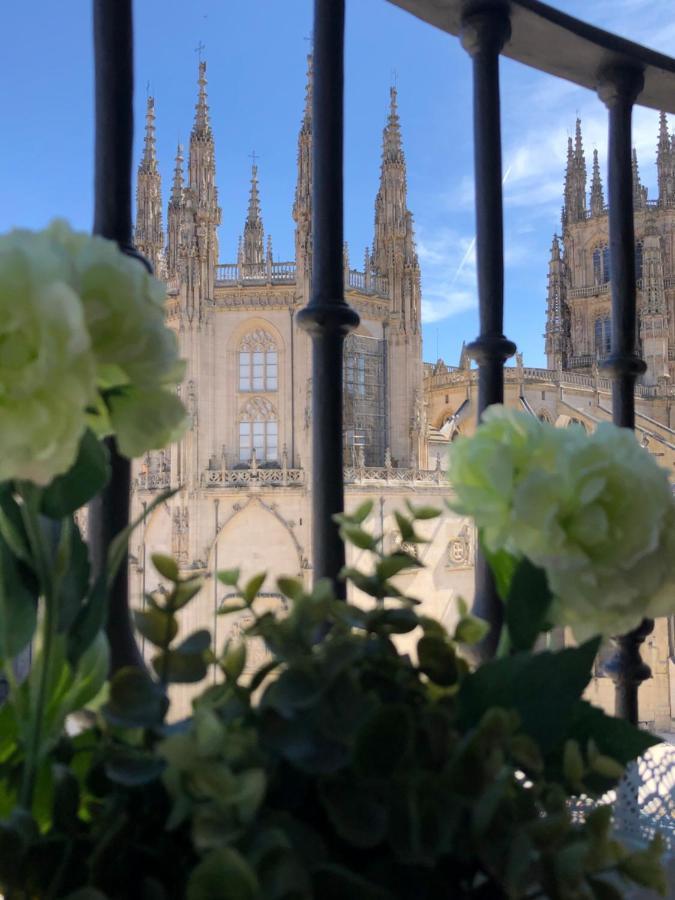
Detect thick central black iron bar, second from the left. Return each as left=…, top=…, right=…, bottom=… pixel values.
left=296, top=0, right=359, bottom=596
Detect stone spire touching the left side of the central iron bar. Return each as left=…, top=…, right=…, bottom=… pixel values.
left=293, top=54, right=314, bottom=299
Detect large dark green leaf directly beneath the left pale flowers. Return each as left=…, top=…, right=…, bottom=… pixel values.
left=41, top=429, right=110, bottom=519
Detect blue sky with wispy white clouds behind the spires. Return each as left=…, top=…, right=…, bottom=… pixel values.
left=0, top=0, right=675, bottom=365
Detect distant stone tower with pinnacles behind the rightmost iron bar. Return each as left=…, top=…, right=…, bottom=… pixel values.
left=545, top=113, right=675, bottom=384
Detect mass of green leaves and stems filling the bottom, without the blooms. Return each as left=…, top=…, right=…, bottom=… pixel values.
left=0, top=494, right=664, bottom=900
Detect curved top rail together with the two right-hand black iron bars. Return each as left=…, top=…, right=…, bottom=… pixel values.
left=390, top=0, right=675, bottom=722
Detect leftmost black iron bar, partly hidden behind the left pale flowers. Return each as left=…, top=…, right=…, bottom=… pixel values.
left=87, top=0, right=147, bottom=671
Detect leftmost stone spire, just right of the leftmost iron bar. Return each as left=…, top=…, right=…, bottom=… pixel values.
left=134, top=97, right=164, bottom=276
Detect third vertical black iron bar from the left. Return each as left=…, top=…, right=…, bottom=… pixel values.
left=461, top=2, right=516, bottom=659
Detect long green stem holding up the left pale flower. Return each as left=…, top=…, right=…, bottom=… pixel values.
left=19, top=482, right=57, bottom=810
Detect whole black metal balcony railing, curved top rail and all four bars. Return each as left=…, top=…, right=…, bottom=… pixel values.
left=89, top=0, right=675, bottom=720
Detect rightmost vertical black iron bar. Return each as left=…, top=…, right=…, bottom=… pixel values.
left=598, top=66, right=654, bottom=725
